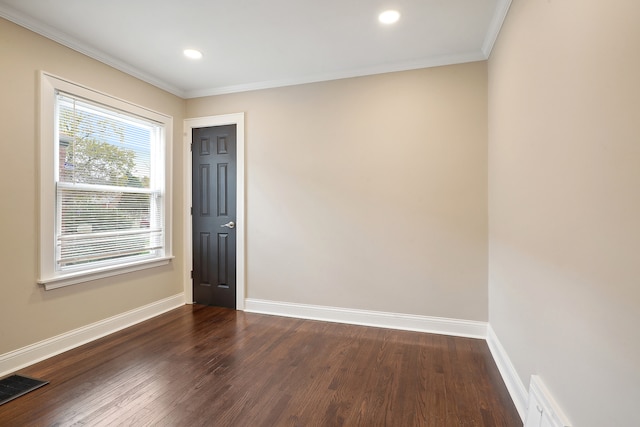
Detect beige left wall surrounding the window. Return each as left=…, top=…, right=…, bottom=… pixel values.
left=0, top=19, right=184, bottom=354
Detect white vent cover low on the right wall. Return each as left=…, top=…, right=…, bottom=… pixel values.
left=524, top=375, right=571, bottom=427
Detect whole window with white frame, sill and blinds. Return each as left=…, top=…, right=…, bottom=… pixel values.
left=39, top=73, right=172, bottom=289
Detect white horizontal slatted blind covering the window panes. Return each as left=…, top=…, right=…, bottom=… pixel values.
left=55, top=91, right=165, bottom=271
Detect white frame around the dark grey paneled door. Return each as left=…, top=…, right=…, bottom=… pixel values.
left=183, top=113, right=245, bottom=310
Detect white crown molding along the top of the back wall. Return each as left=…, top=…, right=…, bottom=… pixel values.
left=185, top=51, right=487, bottom=99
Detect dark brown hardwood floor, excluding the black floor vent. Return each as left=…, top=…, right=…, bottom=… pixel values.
left=0, top=305, right=522, bottom=427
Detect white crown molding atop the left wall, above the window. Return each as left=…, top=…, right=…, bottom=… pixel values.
left=0, top=3, right=185, bottom=98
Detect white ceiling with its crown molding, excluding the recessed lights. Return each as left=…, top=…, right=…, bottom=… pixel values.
left=0, top=0, right=511, bottom=98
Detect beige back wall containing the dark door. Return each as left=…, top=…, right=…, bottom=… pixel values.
left=187, top=62, right=487, bottom=321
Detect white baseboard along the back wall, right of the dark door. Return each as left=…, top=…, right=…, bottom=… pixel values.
left=244, top=298, right=487, bottom=339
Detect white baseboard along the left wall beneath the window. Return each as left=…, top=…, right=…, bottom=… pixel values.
left=0, top=293, right=184, bottom=377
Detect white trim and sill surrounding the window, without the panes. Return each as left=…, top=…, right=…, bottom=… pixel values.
left=37, top=72, right=173, bottom=290
